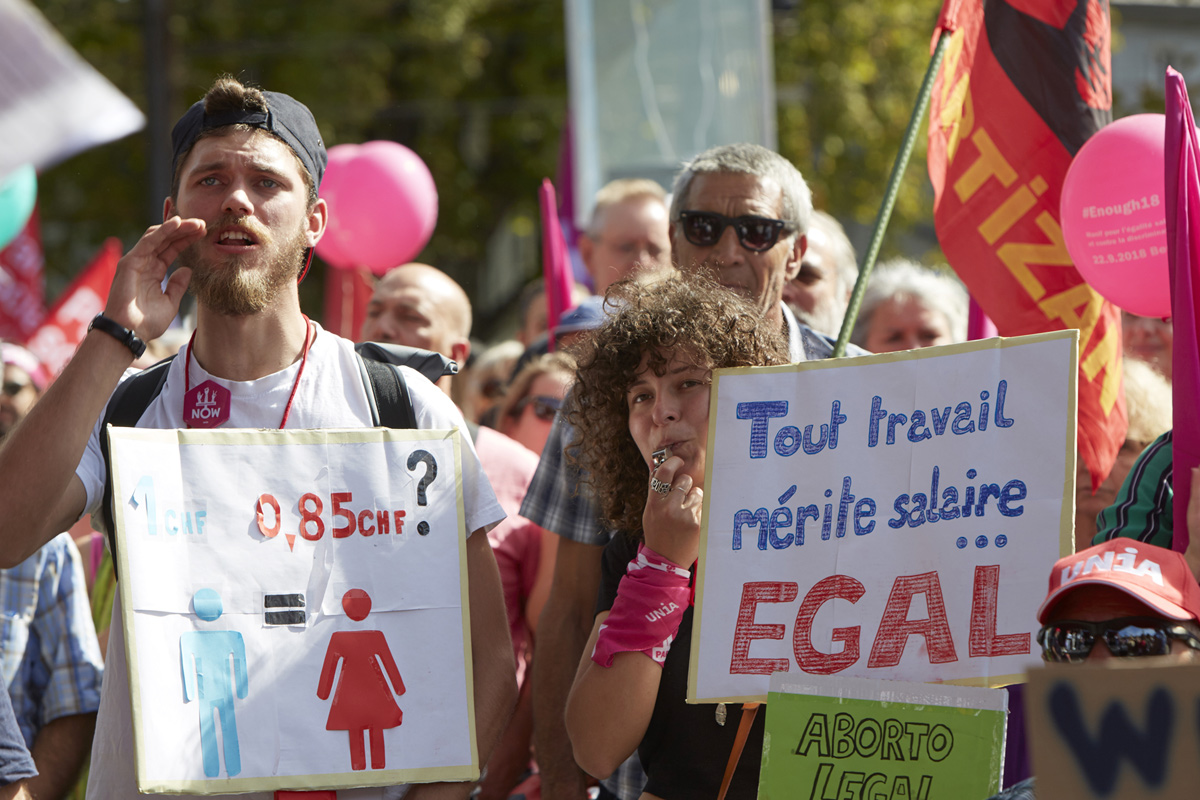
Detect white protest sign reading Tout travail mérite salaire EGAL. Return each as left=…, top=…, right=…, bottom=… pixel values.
left=688, top=331, right=1078, bottom=703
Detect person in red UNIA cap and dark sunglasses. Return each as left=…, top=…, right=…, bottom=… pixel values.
left=992, top=539, right=1200, bottom=800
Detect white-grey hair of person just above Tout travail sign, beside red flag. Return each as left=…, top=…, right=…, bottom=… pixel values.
left=850, top=258, right=967, bottom=347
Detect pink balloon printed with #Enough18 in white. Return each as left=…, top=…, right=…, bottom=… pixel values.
left=1058, top=114, right=1171, bottom=318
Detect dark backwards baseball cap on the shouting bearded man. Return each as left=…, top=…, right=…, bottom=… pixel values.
left=170, top=91, right=329, bottom=187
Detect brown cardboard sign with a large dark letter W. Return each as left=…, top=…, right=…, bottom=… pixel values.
left=1025, top=662, right=1200, bottom=800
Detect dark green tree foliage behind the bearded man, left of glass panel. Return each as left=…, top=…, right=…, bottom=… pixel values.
left=36, top=0, right=566, bottom=331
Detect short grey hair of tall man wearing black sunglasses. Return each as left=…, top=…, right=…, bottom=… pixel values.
left=671, top=143, right=812, bottom=236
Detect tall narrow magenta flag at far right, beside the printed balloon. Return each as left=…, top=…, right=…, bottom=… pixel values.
left=1165, top=67, right=1200, bottom=553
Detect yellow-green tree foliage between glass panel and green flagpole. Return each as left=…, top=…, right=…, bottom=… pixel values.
left=775, top=0, right=942, bottom=256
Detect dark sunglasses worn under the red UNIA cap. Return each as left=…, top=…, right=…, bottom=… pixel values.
left=1038, top=616, right=1200, bottom=663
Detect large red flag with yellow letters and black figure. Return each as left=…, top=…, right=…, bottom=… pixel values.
left=929, top=0, right=1127, bottom=492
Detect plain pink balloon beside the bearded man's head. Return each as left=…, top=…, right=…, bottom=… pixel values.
left=317, top=142, right=438, bottom=275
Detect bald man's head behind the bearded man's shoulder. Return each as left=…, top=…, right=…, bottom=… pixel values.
left=359, top=264, right=470, bottom=391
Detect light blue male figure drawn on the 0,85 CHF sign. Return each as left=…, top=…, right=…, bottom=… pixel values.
left=179, top=589, right=248, bottom=777
